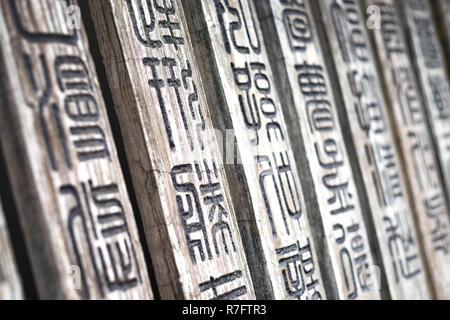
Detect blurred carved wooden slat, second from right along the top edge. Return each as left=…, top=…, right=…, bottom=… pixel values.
left=401, top=0, right=450, bottom=202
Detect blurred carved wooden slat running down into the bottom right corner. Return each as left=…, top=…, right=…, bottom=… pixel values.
left=364, top=0, right=450, bottom=299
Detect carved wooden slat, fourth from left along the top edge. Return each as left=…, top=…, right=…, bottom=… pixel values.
left=254, top=0, right=380, bottom=299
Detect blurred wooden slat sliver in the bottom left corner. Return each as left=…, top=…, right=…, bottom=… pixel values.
left=0, top=200, right=24, bottom=301
